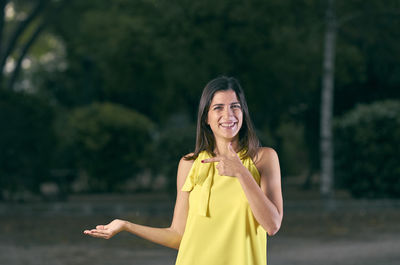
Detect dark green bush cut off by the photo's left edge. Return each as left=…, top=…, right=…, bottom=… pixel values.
left=0, top=90, right=57, bottom=198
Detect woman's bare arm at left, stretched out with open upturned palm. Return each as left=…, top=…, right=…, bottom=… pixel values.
left=84, top=158, right=193, bottom=249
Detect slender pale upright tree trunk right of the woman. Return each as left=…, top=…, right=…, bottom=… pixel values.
left=320, top=0, right=337, bottom=198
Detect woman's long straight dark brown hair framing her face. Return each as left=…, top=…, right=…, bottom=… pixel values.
left=185, top=76, right=260, bottom=160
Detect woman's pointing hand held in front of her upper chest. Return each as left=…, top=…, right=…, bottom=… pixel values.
left=201, top=143, right=247, bottom=177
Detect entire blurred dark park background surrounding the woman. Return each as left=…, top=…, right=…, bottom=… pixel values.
left=0, top=0, right=400, bottom=265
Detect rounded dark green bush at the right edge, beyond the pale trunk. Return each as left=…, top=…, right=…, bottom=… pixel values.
left=335, top=100, right=400, bottom=198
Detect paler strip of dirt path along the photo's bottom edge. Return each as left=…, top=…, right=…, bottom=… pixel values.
left=0, top=234, right=400, bottom=265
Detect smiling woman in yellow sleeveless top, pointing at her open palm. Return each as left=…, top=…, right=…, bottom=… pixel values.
left=84, top=76, right=283, bottom=265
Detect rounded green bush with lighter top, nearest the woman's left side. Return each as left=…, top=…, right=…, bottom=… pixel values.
left=66, top=103, right=154, bottom=192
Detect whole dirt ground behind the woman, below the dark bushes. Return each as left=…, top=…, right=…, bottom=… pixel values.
left=0, top=192, right=400, bottom=265
